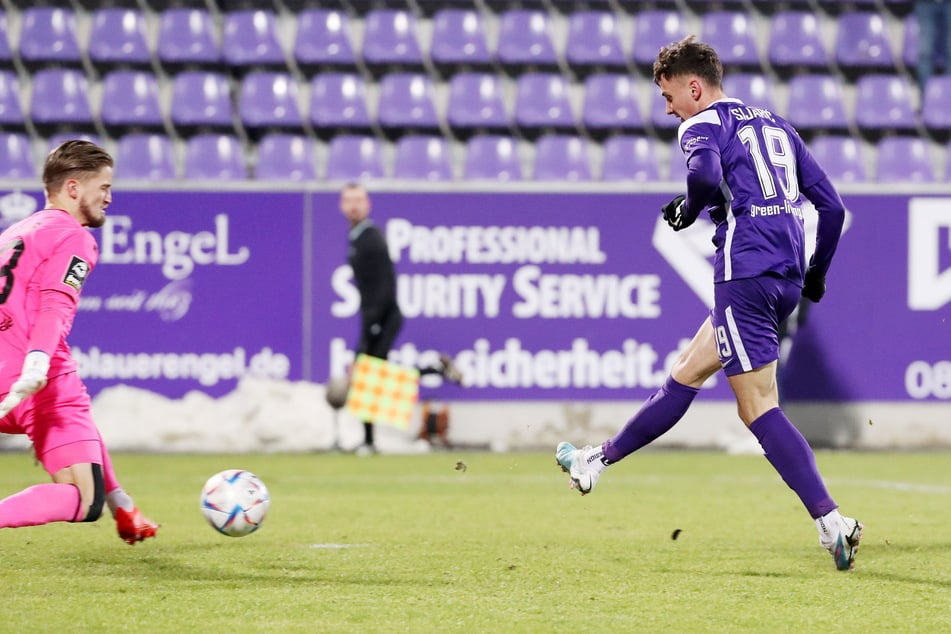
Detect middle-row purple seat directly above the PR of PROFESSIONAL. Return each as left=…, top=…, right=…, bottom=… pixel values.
left=378, top=73, right=439, bottom=133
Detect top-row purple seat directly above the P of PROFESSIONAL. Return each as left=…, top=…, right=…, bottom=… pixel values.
left=363, top=9, right=423, bottom=70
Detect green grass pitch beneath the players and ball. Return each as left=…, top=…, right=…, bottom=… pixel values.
left=0, top=452, right=951, bottom=633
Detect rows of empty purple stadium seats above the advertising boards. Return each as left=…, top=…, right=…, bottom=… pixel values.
left=0, top=0, right=936, bottom=183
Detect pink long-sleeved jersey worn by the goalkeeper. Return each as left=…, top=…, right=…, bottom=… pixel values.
left=0, top=209, right=99, bottom=394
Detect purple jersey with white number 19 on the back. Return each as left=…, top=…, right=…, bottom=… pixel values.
left=678, top=99, right=826, bottom=285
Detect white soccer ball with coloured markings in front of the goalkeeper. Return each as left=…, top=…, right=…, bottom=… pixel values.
left=201, top=469, right=271, bottom=537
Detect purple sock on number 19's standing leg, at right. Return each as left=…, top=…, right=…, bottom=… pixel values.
left=750, top=407, right=838, bottom=519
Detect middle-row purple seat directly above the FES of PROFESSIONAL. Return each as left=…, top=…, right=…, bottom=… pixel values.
left=448, top=73, right=511, bottom=131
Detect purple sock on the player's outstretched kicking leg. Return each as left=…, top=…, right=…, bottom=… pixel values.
left=601, top=376, right=700, bottom=463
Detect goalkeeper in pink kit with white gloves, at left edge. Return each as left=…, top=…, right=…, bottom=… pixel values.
left=0, top=141, right=158, bottom=544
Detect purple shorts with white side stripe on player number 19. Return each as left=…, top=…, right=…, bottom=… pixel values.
left=710, top=276, right=802, bottom=376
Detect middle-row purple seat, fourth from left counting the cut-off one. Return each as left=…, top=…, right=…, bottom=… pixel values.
left=171, top=71, right=234, bottom=132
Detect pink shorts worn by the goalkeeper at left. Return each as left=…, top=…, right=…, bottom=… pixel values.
left=0, top=372, right=102, bottom=475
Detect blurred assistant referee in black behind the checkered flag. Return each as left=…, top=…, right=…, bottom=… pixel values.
left=340, top=183, right=462, bottom=455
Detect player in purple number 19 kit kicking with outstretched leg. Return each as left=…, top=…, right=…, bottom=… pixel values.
left=555, top=36, right=863, bottom=570
